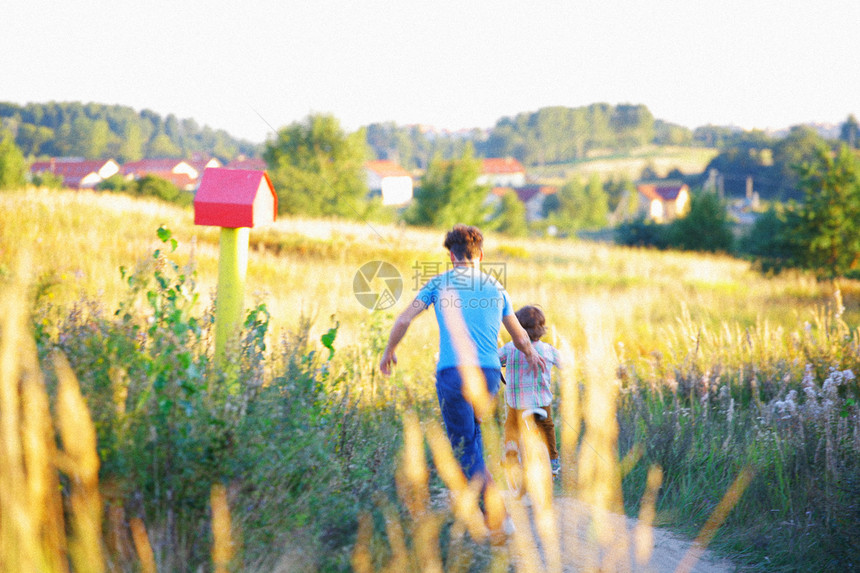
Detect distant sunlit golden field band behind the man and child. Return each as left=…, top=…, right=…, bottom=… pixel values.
left=0, top=190, right=857, bottom=372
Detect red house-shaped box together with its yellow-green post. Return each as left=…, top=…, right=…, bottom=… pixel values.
left=194, top=167, right=278, bottom=362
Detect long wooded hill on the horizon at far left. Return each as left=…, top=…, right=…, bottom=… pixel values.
left=0, top=102, right=259, bottom=163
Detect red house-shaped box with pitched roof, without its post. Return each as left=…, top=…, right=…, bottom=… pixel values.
left=194, top=167, right=278, bottom=229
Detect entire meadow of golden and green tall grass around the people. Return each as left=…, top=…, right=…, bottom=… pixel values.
left=0, top=191, right=860, bottom=571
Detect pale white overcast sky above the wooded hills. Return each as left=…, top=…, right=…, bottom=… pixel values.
left=0, top=0, right=860, bottom=142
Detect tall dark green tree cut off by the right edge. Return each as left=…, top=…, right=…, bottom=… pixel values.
left=788, top=145, right=860, bottom=279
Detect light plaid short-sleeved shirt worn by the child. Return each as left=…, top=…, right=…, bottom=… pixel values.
left=499, top=341, right=561, bottom=410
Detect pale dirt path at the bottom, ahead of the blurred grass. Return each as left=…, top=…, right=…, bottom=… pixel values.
left=506, top=497, right=735, bottom=573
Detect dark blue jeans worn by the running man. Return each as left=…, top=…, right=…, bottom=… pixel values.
left=436, top=368, right=501, bottom=482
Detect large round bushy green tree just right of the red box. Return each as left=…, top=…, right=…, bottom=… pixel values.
left=263, top=114, right=369, bottom=218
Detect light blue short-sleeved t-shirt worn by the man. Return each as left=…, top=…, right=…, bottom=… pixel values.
left=416, top=266, right=514, bottom=370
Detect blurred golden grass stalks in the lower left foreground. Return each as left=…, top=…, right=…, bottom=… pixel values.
left=0, top=244, right=239, bottom=573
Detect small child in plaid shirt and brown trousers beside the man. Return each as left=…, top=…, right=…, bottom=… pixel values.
left=499, top=306, right=561, bottom=477
